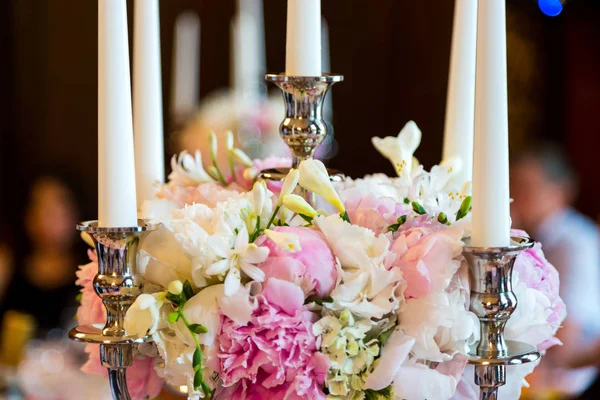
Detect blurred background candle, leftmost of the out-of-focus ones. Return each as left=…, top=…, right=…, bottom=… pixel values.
left=171, top=11, right=200, bottom=122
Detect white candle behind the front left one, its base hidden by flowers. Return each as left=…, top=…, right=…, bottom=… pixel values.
left=133, top=0, right=165, bottom=209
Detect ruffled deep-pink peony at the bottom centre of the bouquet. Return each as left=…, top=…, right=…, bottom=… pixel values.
left=215, top=278, right=329, bottom=400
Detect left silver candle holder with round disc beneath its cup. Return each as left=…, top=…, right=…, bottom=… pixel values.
left=69, top=220, right=155, bottom=400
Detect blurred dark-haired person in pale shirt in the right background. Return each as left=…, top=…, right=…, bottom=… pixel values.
left=510, top=145, right=600, bottom=399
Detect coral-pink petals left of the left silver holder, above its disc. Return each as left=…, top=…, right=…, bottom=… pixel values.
left=75, top=250, right=106, bottom=325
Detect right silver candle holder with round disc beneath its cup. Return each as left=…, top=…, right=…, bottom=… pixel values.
left=463, top=237, right=540, bottom=400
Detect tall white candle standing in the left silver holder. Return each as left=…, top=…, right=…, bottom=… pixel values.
left=98, top=0, right=137, bottom=227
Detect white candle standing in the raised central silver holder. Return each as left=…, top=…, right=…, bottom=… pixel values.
left=285, top=0, right=322, bottom=76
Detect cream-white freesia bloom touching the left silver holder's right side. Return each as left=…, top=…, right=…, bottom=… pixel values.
left=125, top=292, right=166, bottom=337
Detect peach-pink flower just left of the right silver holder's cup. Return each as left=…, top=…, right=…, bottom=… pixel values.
left=391, top=224, right=463, bottom=298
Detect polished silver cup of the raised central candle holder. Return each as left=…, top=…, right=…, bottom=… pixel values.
left=265, top=74, right=344, bottom=168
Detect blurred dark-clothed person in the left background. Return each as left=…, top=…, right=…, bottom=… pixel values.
left=0, top=173, right=85, bottom=336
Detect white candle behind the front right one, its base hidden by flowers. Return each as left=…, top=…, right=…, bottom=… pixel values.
left=443, top=0, right=477, bottom=183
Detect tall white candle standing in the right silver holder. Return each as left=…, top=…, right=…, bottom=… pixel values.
left=471, top=0, right=510, bottom=247
